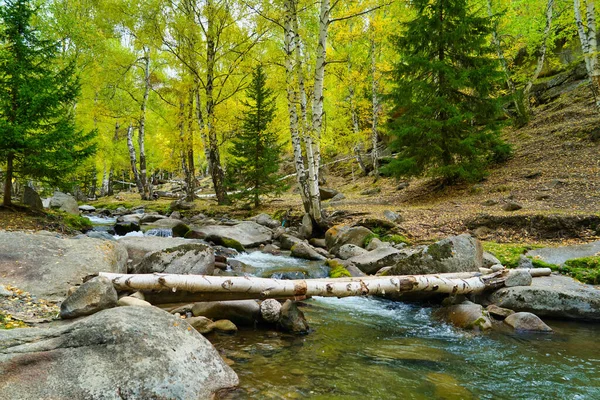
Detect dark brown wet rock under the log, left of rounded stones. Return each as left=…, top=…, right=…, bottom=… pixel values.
left=192, top=300, right=260, bottom=326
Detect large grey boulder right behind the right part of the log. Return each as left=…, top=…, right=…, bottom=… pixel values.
left=391, top=234, right=483, bottom=275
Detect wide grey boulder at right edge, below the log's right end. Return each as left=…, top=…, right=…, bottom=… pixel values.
left=489, top=275, right=600, bottom=321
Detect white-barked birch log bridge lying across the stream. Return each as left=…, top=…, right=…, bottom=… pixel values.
left=100, top=268, right=550, bottom=304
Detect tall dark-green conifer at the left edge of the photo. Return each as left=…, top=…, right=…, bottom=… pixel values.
left=0, top=0, right=95, bottom=206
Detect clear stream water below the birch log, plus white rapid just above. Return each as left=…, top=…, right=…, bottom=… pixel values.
left=209, top=253, right=600, bottom=399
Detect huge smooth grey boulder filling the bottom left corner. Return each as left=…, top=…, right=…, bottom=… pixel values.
left=0, top=307, right=238, bottom=399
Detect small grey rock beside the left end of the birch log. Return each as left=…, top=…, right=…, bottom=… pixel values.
left=60, top=276, right=118, bottom=319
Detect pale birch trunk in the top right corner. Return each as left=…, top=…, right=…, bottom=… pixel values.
left=573, top=0, right=600, bottom=110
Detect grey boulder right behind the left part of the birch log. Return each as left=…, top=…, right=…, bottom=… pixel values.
left=132, top=243, right=215, bottom=275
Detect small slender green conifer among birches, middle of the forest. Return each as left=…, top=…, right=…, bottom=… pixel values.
left=229, top=66, right=285, bottom=206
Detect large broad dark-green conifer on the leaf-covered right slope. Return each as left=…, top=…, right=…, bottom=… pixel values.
left=387, top=0, right=510, bottom=183
